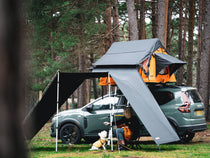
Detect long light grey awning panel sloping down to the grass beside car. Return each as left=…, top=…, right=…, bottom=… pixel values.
left=94, top=68, right=179, bottom=145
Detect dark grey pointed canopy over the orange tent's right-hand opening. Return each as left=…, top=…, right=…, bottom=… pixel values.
left=155, top=53, right=186, bottom=75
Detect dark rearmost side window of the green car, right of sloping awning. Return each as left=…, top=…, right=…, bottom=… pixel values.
left=152, top=91, right=174, bottom=105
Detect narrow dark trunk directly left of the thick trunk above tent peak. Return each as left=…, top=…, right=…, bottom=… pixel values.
left=151, top=0, right=158, bottom=38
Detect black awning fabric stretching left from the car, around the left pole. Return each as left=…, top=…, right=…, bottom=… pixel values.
left=23, top=72, right=107, bottom=140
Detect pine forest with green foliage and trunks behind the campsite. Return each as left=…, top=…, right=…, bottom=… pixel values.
left=25, top=0, right=210, bottom=119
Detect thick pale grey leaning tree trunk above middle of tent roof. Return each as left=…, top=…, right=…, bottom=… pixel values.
left=126, top=0, right=139, bottom=41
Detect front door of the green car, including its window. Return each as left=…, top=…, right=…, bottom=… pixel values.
left=84, top=97, right=119, bottom=136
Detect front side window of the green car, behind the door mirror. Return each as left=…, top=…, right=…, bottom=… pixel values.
left=93, top=97, right=119, bottom=111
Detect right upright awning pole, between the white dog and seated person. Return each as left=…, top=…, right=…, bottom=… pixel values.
left=108, top=73, right=113, bottom=151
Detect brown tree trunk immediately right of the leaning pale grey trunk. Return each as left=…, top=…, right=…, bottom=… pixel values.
left=139, top=0, right=146, bottom=39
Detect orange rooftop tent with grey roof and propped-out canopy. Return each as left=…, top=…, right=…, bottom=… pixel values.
left=96, top=39, right=185, bottom=85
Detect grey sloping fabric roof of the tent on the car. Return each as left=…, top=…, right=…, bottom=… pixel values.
left=93, top=38, right=164, bottom=68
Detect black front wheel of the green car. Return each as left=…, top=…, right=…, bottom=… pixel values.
left=60, top=123, right=81, bottom=144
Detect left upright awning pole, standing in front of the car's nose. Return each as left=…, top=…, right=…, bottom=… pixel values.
left=55, top=70, right=60, bottom=152
